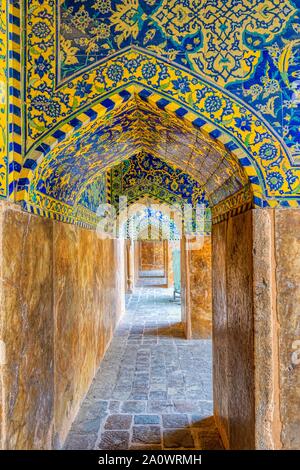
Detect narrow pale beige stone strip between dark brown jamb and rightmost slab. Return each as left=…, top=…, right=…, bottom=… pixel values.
left=252, top=209, right=282, bottom=449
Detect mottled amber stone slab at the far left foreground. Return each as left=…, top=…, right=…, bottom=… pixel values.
left=0, top=203, right=54, bottom=449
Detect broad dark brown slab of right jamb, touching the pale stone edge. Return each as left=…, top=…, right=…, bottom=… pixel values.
left=226, top=211, right=255, bottom=449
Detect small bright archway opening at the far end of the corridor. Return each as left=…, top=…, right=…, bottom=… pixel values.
left=119, top=202, right=180, bottom=290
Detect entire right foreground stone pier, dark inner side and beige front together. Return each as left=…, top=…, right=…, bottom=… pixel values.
left=213, top=209, right=300, bottom=449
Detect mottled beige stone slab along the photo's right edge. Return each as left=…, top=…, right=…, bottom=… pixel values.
left=274, top=209, right=300, bottom=450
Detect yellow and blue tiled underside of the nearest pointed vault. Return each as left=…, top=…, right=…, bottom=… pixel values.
left=30, top=98, right=248, bottom=218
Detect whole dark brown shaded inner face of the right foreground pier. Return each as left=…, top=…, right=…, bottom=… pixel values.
left=212, top=211, right=255, bottom=449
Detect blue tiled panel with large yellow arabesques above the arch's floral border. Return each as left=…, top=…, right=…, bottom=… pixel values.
left=58, top=0, right=300, bottom=161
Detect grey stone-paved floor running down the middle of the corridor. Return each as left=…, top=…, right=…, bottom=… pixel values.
left=65, top=288, right=221, bottom=450
